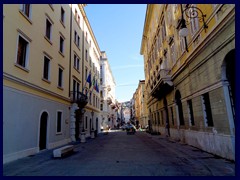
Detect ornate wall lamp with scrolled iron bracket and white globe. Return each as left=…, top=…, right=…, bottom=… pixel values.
left=177, top=4, right=208, bottom=52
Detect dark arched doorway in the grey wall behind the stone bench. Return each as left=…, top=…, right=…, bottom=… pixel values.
left=39, top=112, right=48, bottom=150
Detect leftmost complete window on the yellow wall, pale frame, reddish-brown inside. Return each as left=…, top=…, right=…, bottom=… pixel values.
left=17, top=35, right=29, bottom=68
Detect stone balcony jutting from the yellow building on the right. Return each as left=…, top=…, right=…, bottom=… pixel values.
left=150, top=69, right=173, bottom=99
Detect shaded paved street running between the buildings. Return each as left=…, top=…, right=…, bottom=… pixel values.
left=3, top=132, right=235, bottom=176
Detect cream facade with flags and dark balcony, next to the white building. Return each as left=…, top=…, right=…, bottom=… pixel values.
left=69, top=4, right=101, bottom=142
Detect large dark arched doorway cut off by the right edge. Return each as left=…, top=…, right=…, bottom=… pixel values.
left=222, top=49, right=236, bottom=123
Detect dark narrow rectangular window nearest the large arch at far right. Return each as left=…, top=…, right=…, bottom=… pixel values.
left=202, top=93, right=214, bottom=127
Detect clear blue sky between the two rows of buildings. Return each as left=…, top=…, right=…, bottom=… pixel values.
left=85, top=4, right=147, bottom=102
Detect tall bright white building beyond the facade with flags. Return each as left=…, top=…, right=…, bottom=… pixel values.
left=100, top=51, right=117, bottom=129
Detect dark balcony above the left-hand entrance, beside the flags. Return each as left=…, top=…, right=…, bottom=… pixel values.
left=70, top=91, right=88, bottom=108
